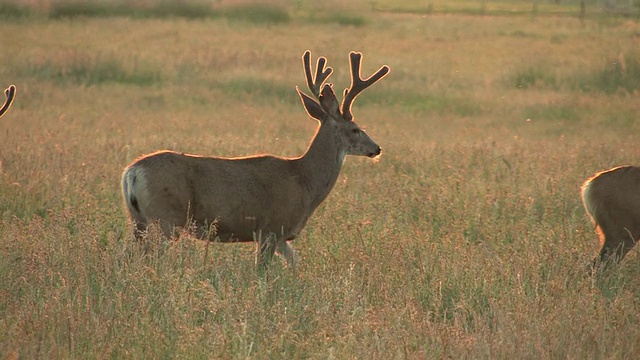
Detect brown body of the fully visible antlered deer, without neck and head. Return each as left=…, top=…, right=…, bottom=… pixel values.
left=124, top=151, right=313, bottom=241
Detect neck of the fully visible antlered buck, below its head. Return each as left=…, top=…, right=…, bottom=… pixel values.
left=299, top=125, right=346, bottom=209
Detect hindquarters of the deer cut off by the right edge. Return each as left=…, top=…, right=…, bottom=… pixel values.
left=582, top=166, right=640, bottom=270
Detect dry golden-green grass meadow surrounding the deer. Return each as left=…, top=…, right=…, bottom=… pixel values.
left=0, top=0, right=640, bottom=359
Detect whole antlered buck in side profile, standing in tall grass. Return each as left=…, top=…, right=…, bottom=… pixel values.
left=122, top=50, right=389, bottom=268
